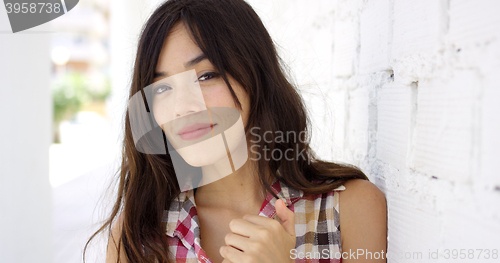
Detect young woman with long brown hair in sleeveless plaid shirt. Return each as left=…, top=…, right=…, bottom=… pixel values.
left=87, top=0, right=387, bottom=263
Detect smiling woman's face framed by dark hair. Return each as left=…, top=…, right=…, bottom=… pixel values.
left=149, top=23, right=250, bottom=170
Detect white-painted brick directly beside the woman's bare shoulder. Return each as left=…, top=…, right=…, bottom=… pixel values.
left=379, top=166, right=442, bottom=262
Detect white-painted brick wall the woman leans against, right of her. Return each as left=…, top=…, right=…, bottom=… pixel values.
left=249, top=0, right=500, bottom=262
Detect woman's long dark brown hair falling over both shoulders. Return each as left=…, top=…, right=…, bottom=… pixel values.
left=84, top=0, right=368, bottom=262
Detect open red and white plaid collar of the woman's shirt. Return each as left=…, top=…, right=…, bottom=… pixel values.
left=162, top=178, right=304, bottom=240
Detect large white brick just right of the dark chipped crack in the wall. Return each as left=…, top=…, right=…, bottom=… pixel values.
left=412, top=70, right=480, bottom=184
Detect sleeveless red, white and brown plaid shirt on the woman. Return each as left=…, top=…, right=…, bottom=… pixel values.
left=163, top=179, right=345, bottom=263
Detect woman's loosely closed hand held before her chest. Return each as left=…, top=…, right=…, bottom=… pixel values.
left=219, top=199, right=296, bottom=263
